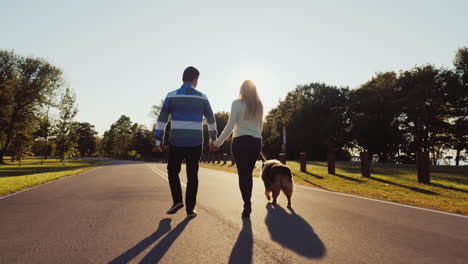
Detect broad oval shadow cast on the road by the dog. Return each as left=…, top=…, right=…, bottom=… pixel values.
left=265, top=203, right=326, bottom=258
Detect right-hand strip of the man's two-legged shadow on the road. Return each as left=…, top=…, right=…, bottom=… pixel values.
left=140, top=218, right=193, bottom=263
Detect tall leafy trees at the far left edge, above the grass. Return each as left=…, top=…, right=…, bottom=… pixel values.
left=0, top=50, right=97, bottom=163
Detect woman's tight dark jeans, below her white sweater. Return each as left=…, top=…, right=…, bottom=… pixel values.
left=232, top=136, right=262, bottom=208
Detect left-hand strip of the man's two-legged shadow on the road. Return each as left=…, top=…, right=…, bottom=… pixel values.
left=109, top=218, right=171, bottom=264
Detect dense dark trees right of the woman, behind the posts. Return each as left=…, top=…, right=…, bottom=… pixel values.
left=263, top=48, right=468, bottom=165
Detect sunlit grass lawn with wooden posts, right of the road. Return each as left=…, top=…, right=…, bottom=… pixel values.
left=200, top=161, right=468, bottom=215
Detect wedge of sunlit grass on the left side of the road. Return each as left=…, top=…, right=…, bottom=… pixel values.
left=0, top=159, right=110, bottom=196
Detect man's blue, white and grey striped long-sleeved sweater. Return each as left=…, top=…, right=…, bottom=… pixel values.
left=154, top=84, right=218, bottom=147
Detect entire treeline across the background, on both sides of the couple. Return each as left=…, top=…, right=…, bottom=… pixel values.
left=4, top=48, right=468, bottom=164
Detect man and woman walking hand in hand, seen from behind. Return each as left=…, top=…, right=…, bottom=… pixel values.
left=155, top=67, right=263, bottom=217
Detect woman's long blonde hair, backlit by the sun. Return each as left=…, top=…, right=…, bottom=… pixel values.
left=239, top=80, right=263, bottom=120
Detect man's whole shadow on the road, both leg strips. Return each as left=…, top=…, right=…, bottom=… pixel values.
left=109, top=218, right=193, bottom=264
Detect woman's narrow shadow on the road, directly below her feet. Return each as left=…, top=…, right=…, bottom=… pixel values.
left=229, top=218, right=253, bottom=264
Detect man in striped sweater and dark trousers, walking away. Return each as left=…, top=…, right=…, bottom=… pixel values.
left=154, top=66, right=218, bottom=217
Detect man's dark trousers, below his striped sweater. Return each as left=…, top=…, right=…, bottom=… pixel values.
left=167, top=146, right=202, bottom=212
